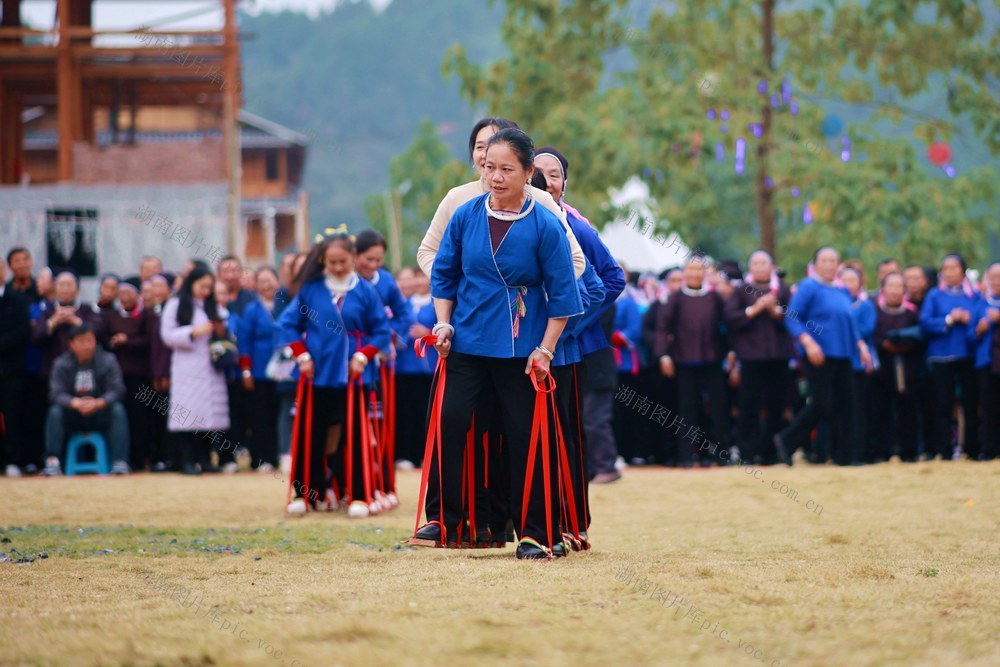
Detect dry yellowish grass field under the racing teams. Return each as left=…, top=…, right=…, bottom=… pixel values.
left=0, top=462, right=1000, bottom=667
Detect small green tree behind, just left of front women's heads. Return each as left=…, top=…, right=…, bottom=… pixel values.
left=365, top=119, right=475, bottom=268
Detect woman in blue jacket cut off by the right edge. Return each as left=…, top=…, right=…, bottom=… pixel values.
left=968, top=262, right=1000, bottom=461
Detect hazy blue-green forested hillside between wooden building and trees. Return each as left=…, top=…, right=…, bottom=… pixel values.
left=241, top=0, right=503, bottom=235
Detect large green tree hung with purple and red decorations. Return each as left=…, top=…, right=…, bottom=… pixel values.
left=444, top=0, right=1000, bottom=275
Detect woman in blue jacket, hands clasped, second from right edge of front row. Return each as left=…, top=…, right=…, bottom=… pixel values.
left=920, top=254, right=980, bottom=461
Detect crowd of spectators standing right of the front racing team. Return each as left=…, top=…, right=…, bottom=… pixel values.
left=612, top=248, right=1000, bottom=467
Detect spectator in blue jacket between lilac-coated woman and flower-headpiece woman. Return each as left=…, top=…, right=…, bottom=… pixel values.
left=241, top=266, right=288, bottom=473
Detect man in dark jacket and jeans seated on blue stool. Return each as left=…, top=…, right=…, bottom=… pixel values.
left=43, top=324, right=130, bottom=476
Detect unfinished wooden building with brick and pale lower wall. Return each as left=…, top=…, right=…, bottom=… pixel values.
left=0, top=0, right=308, bottom=292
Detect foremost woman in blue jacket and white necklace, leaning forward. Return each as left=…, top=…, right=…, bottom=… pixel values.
left=414, top=129, right=583, bottom=558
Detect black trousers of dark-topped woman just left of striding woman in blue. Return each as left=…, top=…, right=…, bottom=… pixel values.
left=737, top=359, right=790, bottom=464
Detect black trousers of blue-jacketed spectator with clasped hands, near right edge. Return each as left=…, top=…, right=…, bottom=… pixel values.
left=927, top=359, right=979, bottom=461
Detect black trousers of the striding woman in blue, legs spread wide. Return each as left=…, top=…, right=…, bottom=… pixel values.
left=781, top=357, right=861, bottom=465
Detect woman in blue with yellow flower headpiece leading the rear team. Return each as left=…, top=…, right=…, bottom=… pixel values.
left=278, top=237, right=388, bottom=516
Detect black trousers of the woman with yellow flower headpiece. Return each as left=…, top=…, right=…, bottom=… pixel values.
left=292, top=386, right=347, bottom=503
